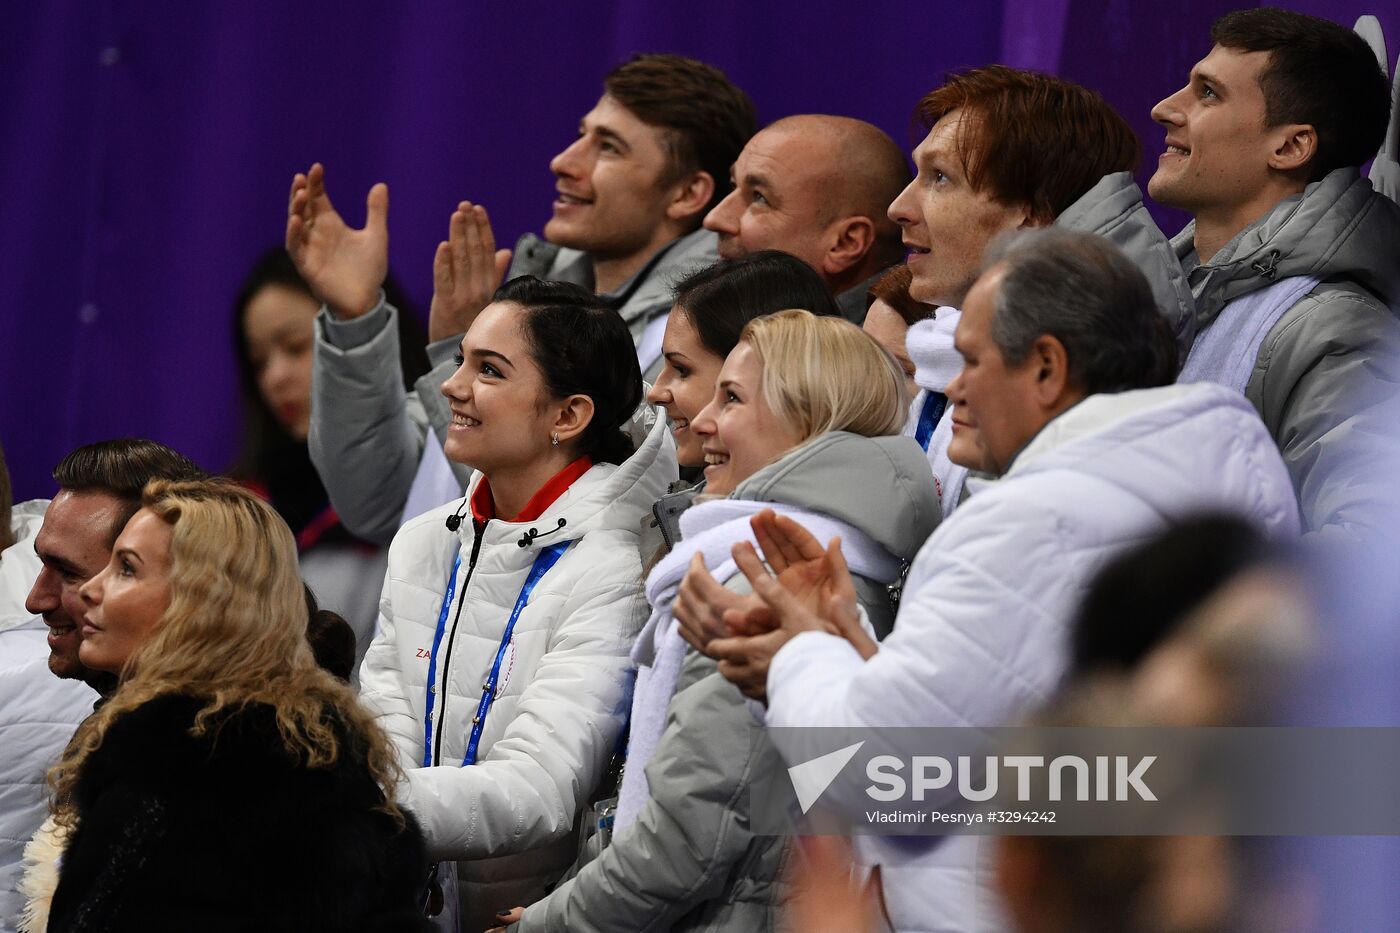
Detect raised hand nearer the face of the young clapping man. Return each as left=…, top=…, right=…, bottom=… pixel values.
left=428, top=200, right=511, bottom=340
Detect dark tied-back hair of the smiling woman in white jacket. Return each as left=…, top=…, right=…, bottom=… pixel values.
left=494, top=276, right=641, bottom=464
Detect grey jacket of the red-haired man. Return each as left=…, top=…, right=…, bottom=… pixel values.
left=1054, top=172, right=1196, bottom=357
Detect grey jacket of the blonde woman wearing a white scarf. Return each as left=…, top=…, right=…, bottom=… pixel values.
left=512, top=431, right=939, bottom=933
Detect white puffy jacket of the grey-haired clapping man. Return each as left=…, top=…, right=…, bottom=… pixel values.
left=767, top=385, right=1299, bottom=933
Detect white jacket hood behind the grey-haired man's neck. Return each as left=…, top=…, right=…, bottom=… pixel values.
left=1007, top=382, right=1299, bottom=535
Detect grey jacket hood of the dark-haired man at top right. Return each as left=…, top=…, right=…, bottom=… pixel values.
left=1172, top=168, right=1400, bottom=326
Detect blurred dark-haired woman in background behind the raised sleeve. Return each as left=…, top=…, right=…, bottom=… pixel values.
left=230, top=247, right=428, bottom=664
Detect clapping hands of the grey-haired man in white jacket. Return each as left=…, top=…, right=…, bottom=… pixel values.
left=672, top=509, right=879, bottom=702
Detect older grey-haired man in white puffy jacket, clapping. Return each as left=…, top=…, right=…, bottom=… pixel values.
left=700, top=230, right=1299, bottom=933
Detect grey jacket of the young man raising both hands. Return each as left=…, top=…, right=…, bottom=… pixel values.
left=308, top=230, right=718, bottom=545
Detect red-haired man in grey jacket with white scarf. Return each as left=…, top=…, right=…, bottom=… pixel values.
left=889, top=64, right=1193, bottom=518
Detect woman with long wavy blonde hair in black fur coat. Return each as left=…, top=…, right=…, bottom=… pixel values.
left=29, top=481, right=427, bottom=930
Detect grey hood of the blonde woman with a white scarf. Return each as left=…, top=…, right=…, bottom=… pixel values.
left=734, top=431, right=941, bottom=560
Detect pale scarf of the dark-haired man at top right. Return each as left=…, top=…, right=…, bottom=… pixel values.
left=1176, top=276, right=1319, bottom=392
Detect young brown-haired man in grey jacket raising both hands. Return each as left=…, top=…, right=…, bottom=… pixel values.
left=287, top=55, right=755, bottom=544
